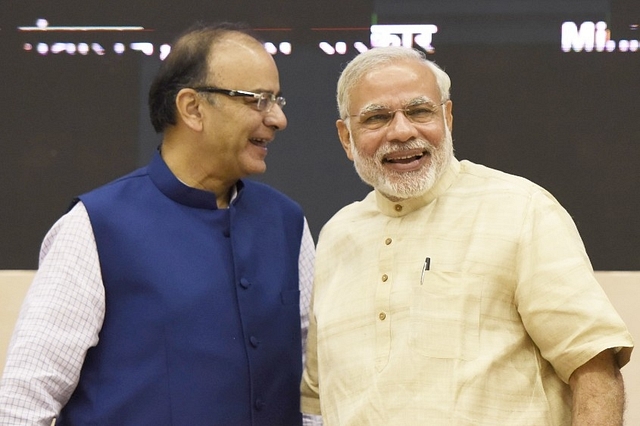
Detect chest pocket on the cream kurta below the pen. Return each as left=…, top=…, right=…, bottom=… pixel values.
left=410, top=271, right=484, bottom=360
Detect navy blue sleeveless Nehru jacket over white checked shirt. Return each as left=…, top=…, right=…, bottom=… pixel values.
left=57, top=154, right=304, bottom=426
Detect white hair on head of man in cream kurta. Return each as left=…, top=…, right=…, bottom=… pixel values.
left=336, top=46, right=451, bottom=119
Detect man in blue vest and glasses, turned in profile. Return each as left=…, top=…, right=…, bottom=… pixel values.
left=0, top=25, right=314, bottom=426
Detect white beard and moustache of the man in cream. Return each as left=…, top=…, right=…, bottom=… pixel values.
left=349, top=125, right=453, bottom=200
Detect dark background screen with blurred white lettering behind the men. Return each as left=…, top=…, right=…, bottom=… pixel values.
left=0, top=0, right=640, bottom=270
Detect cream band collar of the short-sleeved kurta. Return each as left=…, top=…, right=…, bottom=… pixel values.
left=375, top=157, right=460, bottom=217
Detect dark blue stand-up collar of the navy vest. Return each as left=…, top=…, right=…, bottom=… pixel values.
left=147, top=152, right=244, bottom=210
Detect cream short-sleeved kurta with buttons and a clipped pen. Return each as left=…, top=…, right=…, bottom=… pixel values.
left=302, top=159, right=633, bottom=426
